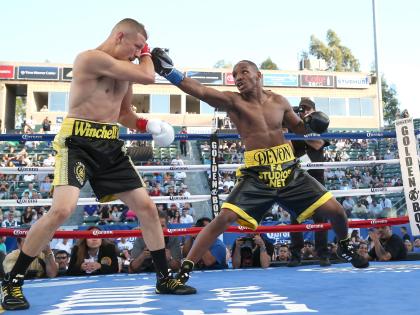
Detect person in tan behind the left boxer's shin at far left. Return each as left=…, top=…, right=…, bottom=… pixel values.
left=3, top=237, right=58, bottom=279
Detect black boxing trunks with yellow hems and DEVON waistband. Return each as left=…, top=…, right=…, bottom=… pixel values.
left=222, top=143, right=333, bottom=229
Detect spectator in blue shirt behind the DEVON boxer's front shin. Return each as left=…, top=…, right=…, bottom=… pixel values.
left=182, top=217, right=227, bottom=269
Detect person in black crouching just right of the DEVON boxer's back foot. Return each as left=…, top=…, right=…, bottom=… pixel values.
left=365, top=226, right=407, bottom=261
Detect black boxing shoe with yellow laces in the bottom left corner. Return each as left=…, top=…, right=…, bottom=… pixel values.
left=1, top=274, right=29, bottom=310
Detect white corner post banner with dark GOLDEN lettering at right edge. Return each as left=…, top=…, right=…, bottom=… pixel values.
left=395, top=118, right=420, bottom=235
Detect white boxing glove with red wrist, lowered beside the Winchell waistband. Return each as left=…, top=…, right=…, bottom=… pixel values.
left=136, top=118, right=175, bottom=147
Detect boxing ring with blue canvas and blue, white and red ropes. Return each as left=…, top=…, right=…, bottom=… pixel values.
left=0, top=122, right=420, bottom=315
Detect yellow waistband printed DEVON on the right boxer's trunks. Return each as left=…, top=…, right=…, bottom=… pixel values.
left=244, top=143, right=295, bottom=167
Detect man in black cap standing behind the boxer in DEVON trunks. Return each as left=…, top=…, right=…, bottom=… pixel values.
left=287, top=98, right=331, bottom=267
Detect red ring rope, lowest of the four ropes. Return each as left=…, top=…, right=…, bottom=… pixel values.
left=0, top=216, right=408, bottom=239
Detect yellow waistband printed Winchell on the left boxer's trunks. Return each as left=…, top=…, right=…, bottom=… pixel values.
left=60, top=118, right=119, bottom=139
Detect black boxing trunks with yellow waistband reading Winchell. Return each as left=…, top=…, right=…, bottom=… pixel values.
left=53, top=118, right=144, bottom=202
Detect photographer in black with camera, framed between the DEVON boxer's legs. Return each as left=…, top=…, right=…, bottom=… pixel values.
left=232, top=234, right=274, bottom=269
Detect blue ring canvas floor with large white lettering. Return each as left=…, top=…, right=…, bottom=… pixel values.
left=0, top=261, right=420, bottom=315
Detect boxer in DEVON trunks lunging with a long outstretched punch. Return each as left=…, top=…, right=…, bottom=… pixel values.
left=152, top=48, right=368, bottom=288
